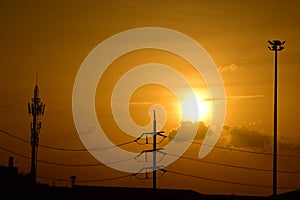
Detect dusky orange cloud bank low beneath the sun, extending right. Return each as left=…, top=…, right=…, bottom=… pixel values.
left=167, top=121, right=300, bottom=154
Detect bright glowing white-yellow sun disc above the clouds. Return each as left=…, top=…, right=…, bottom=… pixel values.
left=182, top=93, right=211, bottom=122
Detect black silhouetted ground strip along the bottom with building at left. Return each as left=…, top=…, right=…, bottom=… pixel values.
left=0, top=157, right=300, bottom=200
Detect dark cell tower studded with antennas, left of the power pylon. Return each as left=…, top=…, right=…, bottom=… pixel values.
left=28, top=77, right=45, bottom=183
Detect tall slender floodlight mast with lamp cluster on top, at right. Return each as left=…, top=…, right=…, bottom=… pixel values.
left=268, top=40, right=285, bottom=196
